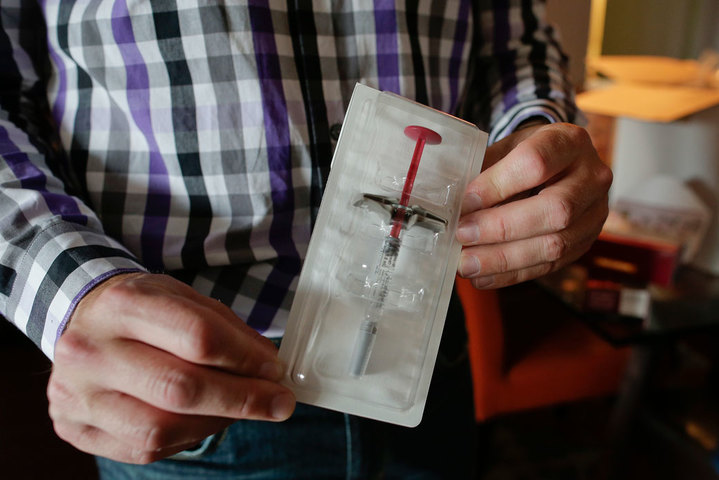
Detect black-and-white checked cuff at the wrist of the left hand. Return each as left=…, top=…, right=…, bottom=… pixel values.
left=8, top=221, right=147, bottom=360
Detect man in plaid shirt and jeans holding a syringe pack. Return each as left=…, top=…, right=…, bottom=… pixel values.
left=0, top=0, right=611, bottom=478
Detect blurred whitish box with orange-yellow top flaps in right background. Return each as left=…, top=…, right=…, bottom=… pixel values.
left=577, top=56, right=719, bottom=275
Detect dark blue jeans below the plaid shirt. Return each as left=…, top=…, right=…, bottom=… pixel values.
left=97, top=292, right=477, bottom=480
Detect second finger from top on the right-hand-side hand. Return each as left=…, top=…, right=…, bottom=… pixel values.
left=457, top=180, right=606, bottom=245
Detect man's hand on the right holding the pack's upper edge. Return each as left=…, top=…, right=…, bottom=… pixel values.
left=457, top=124, right=612, bottom=288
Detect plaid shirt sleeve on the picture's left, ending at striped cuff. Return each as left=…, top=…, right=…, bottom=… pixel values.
left=0, top=2, right=144, bottom=359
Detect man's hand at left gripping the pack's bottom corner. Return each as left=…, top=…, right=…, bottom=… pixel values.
left=48, top=273, right=295, bottom=463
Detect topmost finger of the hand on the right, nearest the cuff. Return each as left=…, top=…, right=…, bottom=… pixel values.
left=462, top=124, right=591, bottom=214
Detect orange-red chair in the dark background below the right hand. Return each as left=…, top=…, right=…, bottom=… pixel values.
left=456, top=278, right=630, bottom=422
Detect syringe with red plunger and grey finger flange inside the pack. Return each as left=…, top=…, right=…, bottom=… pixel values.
left=350, top=125, right=446, bottom=377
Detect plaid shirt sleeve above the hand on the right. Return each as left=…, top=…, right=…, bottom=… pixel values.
left=462, top=0, right=580, bottom=144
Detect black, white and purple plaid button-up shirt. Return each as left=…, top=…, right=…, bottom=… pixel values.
left=0, top=0, right=574, bottom=358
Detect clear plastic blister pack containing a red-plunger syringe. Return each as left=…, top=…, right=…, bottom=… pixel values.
left=280, top=85, right=487, bottom=426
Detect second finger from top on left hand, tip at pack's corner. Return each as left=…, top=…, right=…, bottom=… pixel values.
left=56, top=332, right=295, bottom=421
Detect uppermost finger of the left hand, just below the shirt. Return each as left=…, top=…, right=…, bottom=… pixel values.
left=93, top=278, right=283, bottom=380
